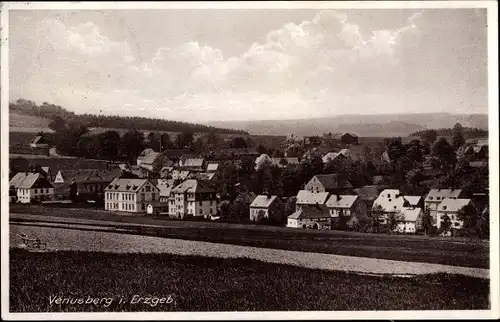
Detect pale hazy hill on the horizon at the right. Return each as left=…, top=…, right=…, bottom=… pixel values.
left=208, top=113, right=488, bottom=137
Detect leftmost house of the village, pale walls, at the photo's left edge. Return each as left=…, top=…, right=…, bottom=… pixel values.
left=9, top=172, right=54, bottom=203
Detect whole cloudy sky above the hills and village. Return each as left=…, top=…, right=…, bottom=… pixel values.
left=9, top=9, right=488, bottom=122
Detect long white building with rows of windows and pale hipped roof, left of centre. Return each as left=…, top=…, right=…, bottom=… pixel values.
left=104, top=178, right=160, bottom=212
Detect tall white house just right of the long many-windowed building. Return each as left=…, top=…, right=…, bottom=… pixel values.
left=168, top=179, right=217, bottom=219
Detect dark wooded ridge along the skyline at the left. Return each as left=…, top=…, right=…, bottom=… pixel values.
left=9, top=99, right=248, bottom=134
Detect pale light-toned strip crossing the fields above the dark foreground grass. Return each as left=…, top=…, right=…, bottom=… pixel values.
left=10, top=224, right=490, bottom=278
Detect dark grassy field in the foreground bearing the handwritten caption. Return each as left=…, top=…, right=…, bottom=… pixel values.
left=10, top=250, right=489, bottom=312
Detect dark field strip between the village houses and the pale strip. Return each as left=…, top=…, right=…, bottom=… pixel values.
left=10, top=205, right=489, bottom=268
